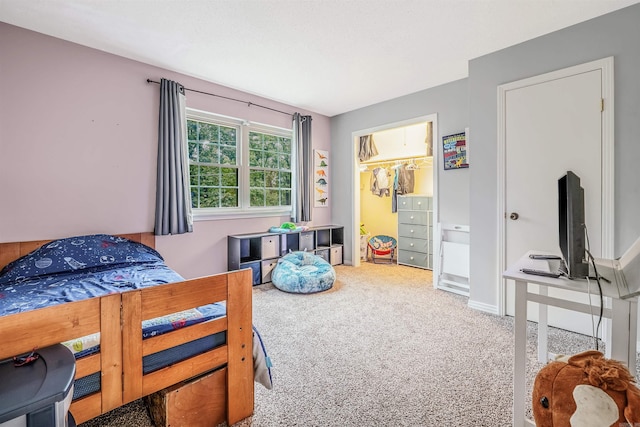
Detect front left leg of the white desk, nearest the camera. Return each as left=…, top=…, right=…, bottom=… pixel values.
left=513, top=280, right=527, bottom=426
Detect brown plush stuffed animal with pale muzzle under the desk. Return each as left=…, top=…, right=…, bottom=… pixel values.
left=533, top=351, right=640, bottom=427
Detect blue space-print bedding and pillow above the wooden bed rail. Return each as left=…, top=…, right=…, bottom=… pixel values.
left=0, top=234, right=184, bottom=316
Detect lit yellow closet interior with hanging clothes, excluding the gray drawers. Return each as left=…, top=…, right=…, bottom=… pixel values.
left=359, top=121, right=434, bottom=269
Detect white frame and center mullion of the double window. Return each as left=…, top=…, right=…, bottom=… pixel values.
left=186, top=108, right=297, bottom=221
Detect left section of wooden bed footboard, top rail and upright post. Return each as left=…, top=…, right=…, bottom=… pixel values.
left=0, top=294, right=122, bottom=423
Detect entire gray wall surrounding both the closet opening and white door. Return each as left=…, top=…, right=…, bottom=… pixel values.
left=331, top=4, right=640, bottom=312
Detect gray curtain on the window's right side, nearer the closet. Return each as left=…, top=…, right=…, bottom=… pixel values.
left=291, top=113, right=313, bottom=223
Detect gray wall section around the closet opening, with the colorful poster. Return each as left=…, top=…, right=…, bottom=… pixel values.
left=331, top=79, right=473, bottom=262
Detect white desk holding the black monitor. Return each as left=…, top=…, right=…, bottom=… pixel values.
left=503, top=251, right=638, bottom=426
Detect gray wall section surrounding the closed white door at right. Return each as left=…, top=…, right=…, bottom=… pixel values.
left=468, top=4, right=640, bottom=308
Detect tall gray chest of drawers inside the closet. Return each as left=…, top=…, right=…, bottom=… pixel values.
left=398, top=194, right=433, bottom=269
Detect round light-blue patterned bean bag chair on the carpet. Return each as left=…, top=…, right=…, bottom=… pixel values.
left=271, top=251, right=336, bottom=294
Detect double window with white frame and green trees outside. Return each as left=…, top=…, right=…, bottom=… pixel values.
left=187, top=109, right=293, bottom=217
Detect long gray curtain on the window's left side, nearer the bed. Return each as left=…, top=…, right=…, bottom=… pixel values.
left=155, top=79, right=193, bottom=235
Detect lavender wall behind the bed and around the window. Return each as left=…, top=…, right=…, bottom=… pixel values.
left=0, top=22, right=331, bottom=278
